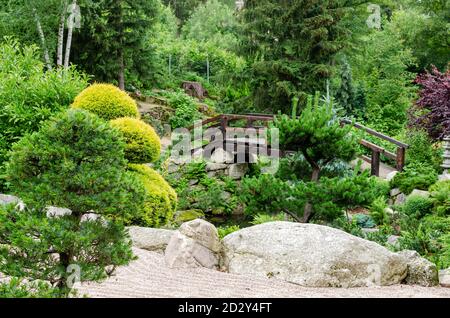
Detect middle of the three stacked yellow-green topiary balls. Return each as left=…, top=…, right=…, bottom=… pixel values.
left=111, top=117, right=161, bottom=163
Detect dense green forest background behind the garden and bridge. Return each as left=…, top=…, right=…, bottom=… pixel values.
left=0, top=0, right=450, bottom=136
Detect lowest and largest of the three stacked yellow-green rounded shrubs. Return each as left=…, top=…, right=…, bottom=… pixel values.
left=129, top=164, right=177, bottom=227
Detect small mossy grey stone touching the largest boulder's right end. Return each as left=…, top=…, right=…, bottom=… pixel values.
left=398, top=251, right=439, bottom=287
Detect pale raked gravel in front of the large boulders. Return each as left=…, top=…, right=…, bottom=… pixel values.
left=78, top=249, right=450, bottom=298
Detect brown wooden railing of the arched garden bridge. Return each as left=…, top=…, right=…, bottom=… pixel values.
left=189, top=114, right=409, bottom=176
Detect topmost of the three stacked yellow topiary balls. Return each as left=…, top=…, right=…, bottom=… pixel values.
left=72, top=84, right=140, bottom=120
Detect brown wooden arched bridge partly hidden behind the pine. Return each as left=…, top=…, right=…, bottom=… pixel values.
left=189, top=114, right=409, bottom=176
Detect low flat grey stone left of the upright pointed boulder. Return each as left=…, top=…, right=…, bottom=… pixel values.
left=128, top=226, right=175, bottom=253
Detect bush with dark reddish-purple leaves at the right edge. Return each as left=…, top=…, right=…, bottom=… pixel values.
left=411, top=66, right=450, bottom=140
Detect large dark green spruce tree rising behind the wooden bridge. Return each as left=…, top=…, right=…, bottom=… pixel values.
left=241, top=0, right=355, bottom=112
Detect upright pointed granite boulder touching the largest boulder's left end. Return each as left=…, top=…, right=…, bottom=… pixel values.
left=164, top=219, right=221, bottom=269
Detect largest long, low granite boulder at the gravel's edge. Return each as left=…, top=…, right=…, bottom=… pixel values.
left=223, top=222, right=407, bottom=287
